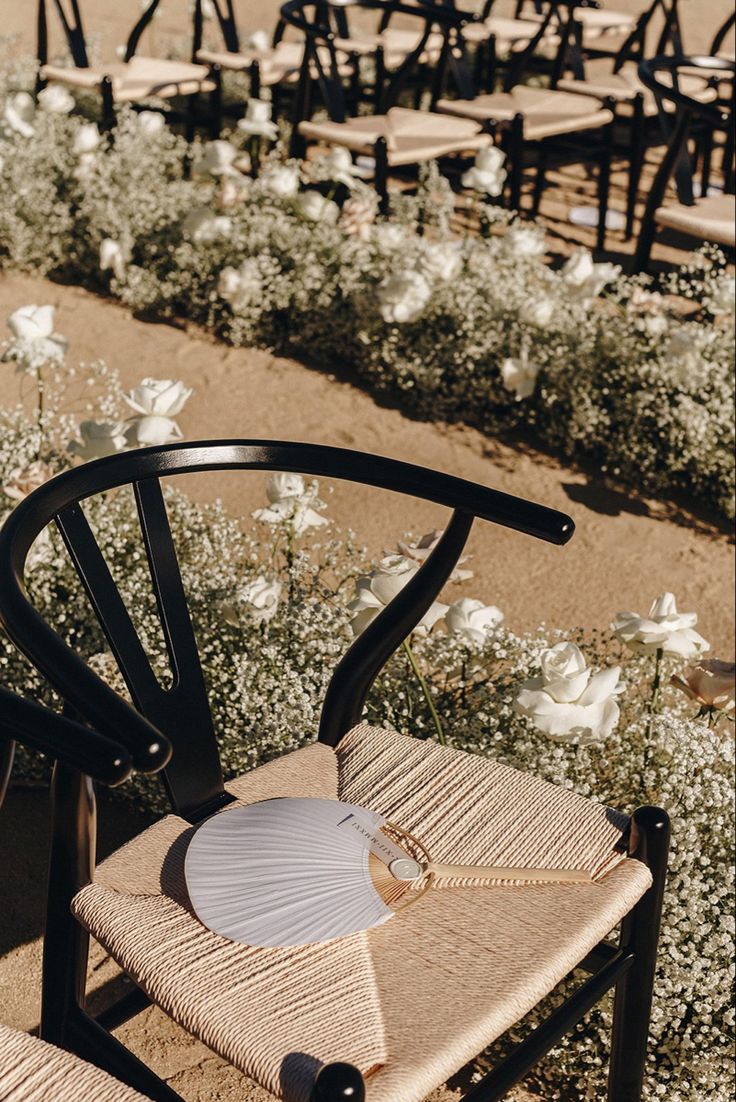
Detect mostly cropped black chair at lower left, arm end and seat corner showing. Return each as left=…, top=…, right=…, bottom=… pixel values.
left=0, top=688, right=156, bottom=1102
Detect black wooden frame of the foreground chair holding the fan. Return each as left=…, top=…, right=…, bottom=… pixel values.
left=0, top=441, right=669, bottom=1102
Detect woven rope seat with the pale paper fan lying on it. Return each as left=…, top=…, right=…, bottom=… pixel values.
left=73, top=724, right=651, bottom=1102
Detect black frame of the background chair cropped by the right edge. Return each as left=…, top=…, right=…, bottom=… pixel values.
left=634, top=55, right=736, bottom=272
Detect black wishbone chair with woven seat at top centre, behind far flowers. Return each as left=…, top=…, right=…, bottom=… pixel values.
left=281, top=0, right=490, bottom=212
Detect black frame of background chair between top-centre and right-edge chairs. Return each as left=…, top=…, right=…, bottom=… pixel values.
left=432, top=0, right=616, bottom=249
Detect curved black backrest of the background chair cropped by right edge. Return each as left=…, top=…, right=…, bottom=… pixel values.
left=639, top=55, right=736, bottom=208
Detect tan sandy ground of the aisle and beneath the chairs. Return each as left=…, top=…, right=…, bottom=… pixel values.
left=0, top=0, right=734, bottom=1102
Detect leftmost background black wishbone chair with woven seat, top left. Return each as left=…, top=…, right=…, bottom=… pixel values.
left=36, top=0, right=220, bottom=140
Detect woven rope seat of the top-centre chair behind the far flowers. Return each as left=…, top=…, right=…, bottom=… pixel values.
left=299, top=107, right=490, bottom=165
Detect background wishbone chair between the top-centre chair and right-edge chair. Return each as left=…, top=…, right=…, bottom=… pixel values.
left=433, top=0, right=615, bottom=249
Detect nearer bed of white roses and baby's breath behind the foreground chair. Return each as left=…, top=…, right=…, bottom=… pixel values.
left=0, top=319, right=734, bottom=1102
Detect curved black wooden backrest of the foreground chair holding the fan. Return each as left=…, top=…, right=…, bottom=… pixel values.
left=0, top=441, right=574, bottom=821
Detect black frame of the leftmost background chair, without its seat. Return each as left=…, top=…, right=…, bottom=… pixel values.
left=36, top=0, right=221, bottom=141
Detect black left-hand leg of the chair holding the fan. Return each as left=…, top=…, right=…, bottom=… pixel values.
left=41, top=761, right=96, bottom=1047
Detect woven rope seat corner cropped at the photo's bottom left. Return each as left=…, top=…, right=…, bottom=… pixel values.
left=0, top=1025, right=145, bottom=1102
